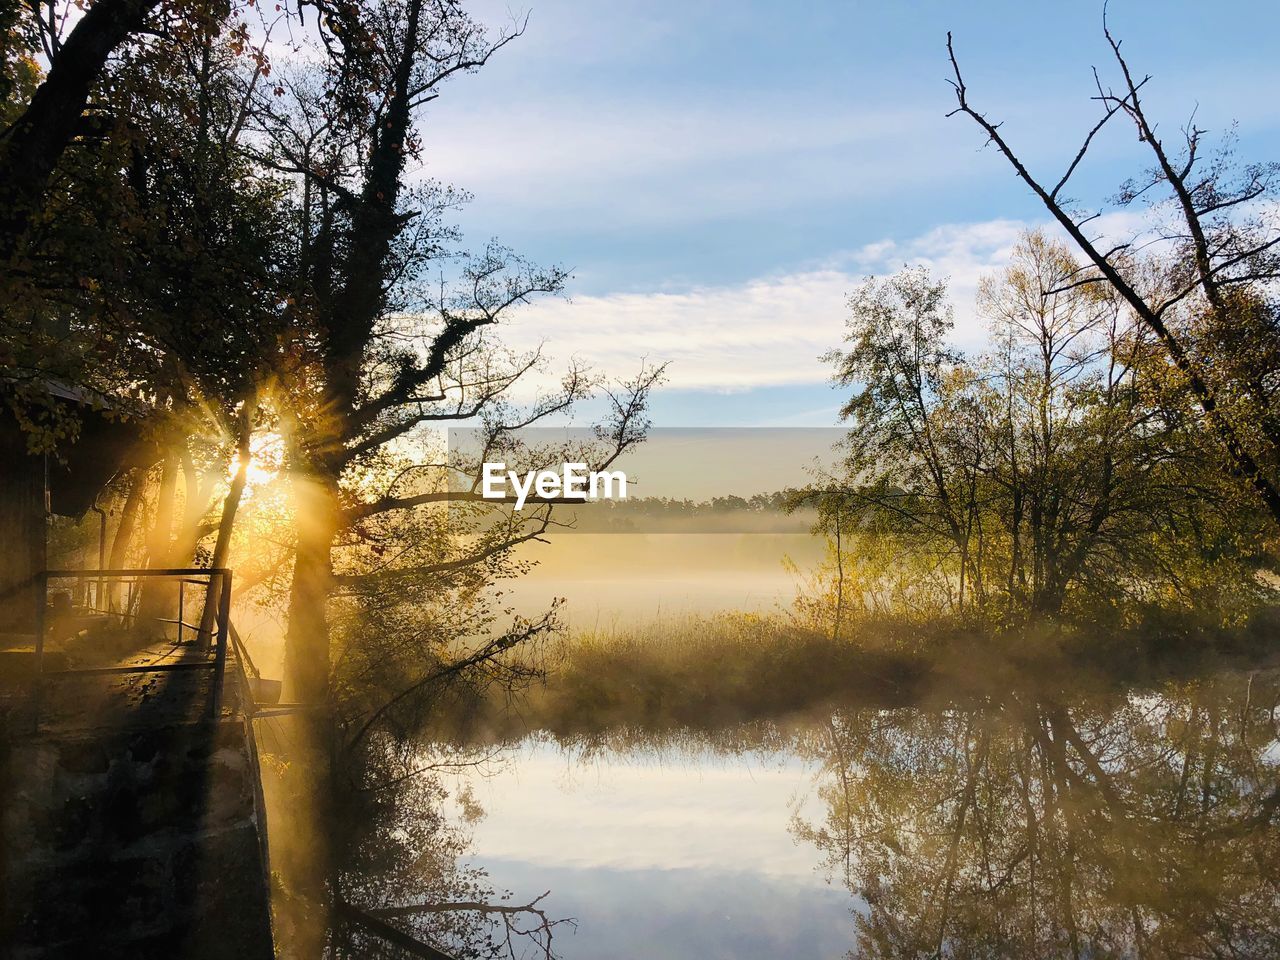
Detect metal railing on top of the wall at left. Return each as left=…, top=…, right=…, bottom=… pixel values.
left=35, top=567, right=232, bottom=726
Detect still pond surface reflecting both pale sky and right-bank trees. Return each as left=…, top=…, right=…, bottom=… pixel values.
left=430, top=675, right=1280, bottom=957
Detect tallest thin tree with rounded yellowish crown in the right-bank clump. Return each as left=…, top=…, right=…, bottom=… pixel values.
left=978, top=233, right=1157, bottom=613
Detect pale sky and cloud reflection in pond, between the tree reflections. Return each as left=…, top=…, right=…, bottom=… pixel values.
left=445, top=736, right=852, bottom=960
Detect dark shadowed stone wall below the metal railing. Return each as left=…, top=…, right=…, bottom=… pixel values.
left=0, top=718, right=273, bottom=960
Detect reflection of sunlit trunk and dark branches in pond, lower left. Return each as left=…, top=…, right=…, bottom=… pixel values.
left=268, top=721, right=575, bottom=960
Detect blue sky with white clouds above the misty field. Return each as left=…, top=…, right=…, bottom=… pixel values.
left=409, top=0, right=1280, bottom=426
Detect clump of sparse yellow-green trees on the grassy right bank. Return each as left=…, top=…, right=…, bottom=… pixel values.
left=806, top=240, right=1263, bottom=620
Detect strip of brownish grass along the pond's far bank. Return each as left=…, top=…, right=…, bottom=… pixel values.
left=453, top=604, right=1277, bottom=735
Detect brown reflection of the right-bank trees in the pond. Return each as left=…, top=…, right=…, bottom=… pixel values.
left=794, top=676, right=1280, bottom=957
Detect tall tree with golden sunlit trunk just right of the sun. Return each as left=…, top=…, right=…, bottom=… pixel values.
left=245, top=0, right=670, bottom=703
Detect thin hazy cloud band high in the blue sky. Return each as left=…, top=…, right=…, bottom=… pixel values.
left=414, top=92, right=987, bottom=230
